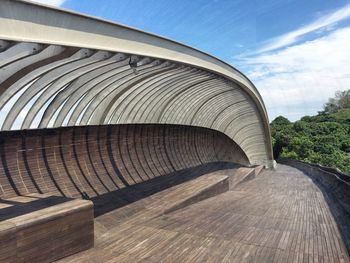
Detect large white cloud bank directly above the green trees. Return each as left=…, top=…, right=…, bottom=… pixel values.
left=241, top=27, right=350, bottom=120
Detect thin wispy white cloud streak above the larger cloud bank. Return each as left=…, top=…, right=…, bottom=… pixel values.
left=257, top=4, right=350, bottom=53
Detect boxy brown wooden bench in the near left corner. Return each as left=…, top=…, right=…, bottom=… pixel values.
left=0, top=194, right=94, bottom=263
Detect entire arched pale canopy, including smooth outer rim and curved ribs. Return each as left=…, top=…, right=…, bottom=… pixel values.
left=0, top=0, right=273, bottom=165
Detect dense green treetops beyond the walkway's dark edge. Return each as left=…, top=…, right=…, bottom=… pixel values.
left=271, top=90, right=350, bottom=173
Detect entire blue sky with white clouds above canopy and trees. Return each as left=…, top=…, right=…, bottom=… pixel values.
left=32, top=0, right=350, bottom=120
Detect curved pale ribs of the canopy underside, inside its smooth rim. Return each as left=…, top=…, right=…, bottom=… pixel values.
left=0, top=40, right=268, bottom=164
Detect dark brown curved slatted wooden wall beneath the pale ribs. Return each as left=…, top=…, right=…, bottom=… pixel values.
left=0, top=124, right=249, bottom=197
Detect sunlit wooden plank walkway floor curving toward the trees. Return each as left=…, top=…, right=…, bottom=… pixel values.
left=58, top=165, right=349, bottom=262
